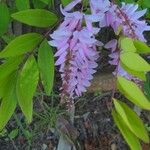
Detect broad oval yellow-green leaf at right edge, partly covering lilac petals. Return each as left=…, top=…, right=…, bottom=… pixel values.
left=120, top=52, right=150, bottom=72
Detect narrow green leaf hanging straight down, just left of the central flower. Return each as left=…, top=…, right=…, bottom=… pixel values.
left=38, top=40, right=54, bottom=95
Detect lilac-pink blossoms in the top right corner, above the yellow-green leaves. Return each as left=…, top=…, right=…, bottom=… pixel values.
left=90, top=0, right=150, bottom=41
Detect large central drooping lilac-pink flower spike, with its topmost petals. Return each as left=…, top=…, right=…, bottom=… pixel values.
left=49, top=0, right=102, bottom=99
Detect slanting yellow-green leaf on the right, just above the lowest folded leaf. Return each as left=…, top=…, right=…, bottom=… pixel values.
left=117, top=76, right=150, bottom=110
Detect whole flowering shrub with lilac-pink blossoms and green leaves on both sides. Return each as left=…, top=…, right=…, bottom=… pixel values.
left=0, top=0, right=150, bottom=150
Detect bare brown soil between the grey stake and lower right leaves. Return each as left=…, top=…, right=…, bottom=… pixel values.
left=74, top=93, right=128, bottom=150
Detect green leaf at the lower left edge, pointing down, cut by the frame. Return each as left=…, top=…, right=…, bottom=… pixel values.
left=0, top=72, right=17, bottom=130
